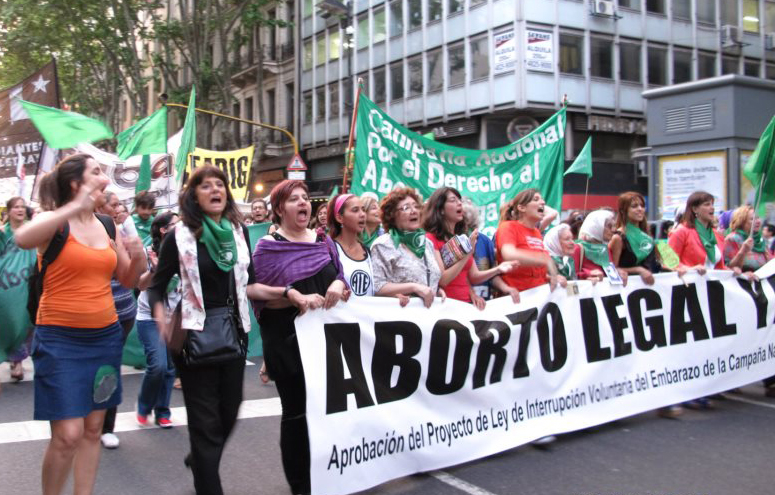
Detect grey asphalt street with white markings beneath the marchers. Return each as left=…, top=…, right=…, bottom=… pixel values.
left=0, top=361, right=775, bottom=495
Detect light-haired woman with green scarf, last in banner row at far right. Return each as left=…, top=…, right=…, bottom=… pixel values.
left=724, top=205, right=772, bottom=273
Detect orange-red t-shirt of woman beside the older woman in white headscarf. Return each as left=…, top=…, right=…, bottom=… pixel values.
left=495, top=220, right=547, bottom=290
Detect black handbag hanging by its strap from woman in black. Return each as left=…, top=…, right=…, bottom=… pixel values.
left=180, top=270, right=248, bottom=368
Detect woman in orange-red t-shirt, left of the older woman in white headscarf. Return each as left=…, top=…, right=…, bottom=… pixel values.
left=495, top=189, right=567, bottom=290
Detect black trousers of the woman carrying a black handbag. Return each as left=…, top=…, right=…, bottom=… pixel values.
left=175, top=359, right=245, bottom=495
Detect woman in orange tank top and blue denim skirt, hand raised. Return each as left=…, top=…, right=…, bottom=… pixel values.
left=16, top=154, right=146, bottom=495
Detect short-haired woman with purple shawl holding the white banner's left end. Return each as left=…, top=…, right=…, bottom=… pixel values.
left=253, top=180, right=349, bottom=494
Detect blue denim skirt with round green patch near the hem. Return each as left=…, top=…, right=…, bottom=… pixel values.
left=31, top=322, right=123, bottom=421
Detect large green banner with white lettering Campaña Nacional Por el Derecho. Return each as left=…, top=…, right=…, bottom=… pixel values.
left=351, top=95, right=565, bottom=235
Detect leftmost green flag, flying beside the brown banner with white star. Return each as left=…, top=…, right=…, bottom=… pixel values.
left=19, top=100, right=113, bottom=149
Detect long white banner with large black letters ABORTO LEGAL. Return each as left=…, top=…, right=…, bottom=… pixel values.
left=296, top=262, right=775, bottom=494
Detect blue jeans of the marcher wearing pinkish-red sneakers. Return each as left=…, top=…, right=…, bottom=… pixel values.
left=137, top=320, right=175, bottom=421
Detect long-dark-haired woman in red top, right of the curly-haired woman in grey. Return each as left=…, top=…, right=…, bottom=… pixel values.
left=423, top=187, right=519, bottom=309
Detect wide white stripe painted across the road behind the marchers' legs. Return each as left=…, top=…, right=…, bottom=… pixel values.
left=0, top=397, right=282, bottom=444
